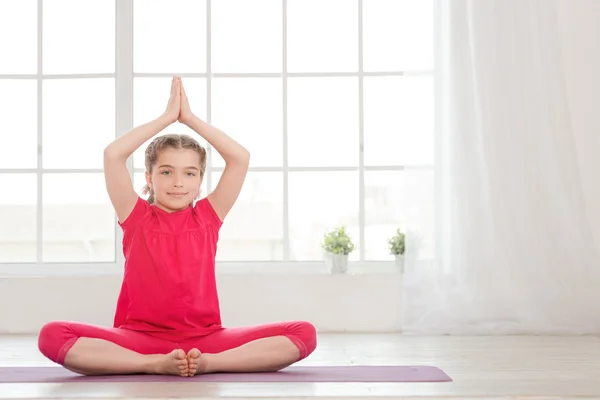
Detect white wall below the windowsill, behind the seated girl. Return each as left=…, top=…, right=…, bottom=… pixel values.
left=0, top=271, right=402, bottom=334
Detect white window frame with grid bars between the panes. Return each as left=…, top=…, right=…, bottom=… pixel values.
left=0, top=0, right=441, bottom=277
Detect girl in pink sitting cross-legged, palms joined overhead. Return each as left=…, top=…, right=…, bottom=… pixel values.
left=38, top=77, right=316, bottom=376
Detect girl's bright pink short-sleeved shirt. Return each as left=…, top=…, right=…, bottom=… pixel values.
left=114, top=198, right=222, bottom=340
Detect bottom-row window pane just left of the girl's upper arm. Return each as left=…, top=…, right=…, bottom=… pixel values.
left=42, top=174, right=116, bottom=262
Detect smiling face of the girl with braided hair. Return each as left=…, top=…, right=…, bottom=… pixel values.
left=146, top=149, right=202, bottom=212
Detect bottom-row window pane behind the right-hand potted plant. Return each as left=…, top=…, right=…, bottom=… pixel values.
left=365, top=169, right=435, bottom=260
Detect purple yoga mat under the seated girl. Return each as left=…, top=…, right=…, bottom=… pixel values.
left=0, top=365, right=452, bottom=383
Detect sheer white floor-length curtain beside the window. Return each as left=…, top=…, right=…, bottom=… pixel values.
left=403, top=0, right=600, bottom=334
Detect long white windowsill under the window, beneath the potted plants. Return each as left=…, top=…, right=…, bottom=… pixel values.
left=0, top=260, right=432, bottom=278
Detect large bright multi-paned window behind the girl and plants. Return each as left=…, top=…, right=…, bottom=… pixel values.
left=0, top=0, right=435, bottom=268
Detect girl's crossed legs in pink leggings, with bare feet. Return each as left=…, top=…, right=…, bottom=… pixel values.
left=38, top=321, right=316, bottom=376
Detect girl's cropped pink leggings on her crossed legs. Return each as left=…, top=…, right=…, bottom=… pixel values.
left=38, top=321, right=317, bottom=365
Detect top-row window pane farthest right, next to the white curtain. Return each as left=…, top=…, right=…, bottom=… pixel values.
left=363, top=0, right=433, bottom=71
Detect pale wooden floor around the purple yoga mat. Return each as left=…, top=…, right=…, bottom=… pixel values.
left=0, top=334, right=600, bottom=400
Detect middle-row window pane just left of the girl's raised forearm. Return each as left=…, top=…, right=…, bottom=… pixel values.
left=42, top=78, right=115, bottom=168
